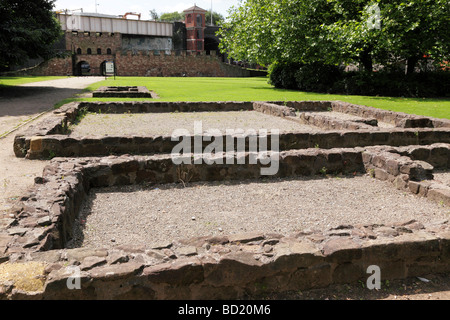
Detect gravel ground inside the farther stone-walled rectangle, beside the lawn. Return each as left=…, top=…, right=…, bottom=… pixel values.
left=71, top=111, right=320, bottom=136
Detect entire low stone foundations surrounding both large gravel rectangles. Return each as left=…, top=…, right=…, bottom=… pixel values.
left=0, top=102, right=450, bottom=299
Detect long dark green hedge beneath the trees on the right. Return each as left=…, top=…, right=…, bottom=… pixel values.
left=269, top=62, right=450, bottom=98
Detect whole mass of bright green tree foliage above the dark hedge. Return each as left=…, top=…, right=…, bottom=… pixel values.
left=219, top=0, right=450, bottom=71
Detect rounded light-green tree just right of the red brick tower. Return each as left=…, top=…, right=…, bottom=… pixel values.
left=219, top=0, right=338, bottom=65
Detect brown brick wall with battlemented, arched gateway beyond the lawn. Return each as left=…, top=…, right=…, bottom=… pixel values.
left=11, top=31, right=264, bottom=77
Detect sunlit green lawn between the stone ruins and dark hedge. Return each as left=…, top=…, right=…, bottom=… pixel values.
left=74, top=77, right=450, bottom=119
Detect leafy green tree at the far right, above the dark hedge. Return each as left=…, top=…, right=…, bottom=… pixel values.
left=323, top=0, right=450, bottom=73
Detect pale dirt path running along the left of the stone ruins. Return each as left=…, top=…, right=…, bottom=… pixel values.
left=0, top=77, right=104, bottom=219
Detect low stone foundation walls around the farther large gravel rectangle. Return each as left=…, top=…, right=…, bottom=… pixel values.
left=14, top=101, right=450, bottom=159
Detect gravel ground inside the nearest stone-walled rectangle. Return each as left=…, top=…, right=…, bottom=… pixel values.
left=70, top=175, right=449, bottom=247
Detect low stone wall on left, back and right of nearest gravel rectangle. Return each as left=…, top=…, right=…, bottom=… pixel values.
left=3, top=144, right=450, bottom=253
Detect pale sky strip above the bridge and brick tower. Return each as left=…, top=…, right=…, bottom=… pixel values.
left=55, top=0, right=240, bottom=20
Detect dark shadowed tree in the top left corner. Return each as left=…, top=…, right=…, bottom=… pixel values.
left=0, top=0, right=62, bottom=70
